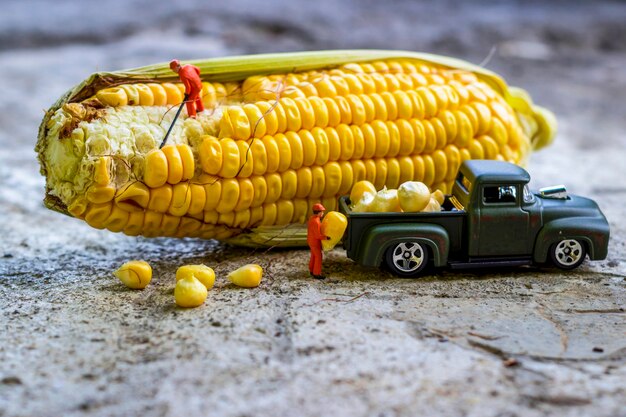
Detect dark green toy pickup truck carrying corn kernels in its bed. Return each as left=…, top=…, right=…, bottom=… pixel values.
left=339, top=160, right=609, bottom=277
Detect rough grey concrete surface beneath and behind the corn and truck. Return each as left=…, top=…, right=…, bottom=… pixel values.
left=0, top=0, right=626, bottom=417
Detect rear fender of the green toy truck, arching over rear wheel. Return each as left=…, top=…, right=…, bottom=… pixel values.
left=359, top=223, right=450, bottom=266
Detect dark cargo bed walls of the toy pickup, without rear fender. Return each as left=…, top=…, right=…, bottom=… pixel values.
left=339, top=196, right=467, bottom=259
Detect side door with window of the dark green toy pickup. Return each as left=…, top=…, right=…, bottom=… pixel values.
left=469, top=184, right=530, bottom=257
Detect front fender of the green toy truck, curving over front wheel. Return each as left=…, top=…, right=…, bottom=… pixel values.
left=533, top=217, right=608, bottom=263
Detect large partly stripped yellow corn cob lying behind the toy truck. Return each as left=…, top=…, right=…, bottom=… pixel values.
left=36, top=51, right=555, bottom=245
